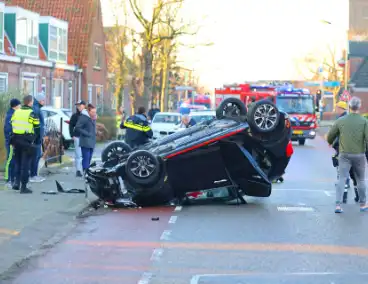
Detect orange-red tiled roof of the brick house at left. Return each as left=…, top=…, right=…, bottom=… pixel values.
left=6, top=0, right=98, bottom=67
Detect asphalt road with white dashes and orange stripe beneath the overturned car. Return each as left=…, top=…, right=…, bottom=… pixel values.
left=6, top=134, right=368, bottom=284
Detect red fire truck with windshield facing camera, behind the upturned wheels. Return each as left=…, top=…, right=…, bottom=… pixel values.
left=215, top=84, right=317, bottom=145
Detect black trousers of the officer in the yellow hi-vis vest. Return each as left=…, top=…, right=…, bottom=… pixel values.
left=14, top=145, right=33, bottom=186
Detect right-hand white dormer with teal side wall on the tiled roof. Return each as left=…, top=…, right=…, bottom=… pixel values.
left=40, top=17, right=68, bottom=63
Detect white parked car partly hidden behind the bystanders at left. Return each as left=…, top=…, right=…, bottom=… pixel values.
left=41, top=106, right=73, bottom=150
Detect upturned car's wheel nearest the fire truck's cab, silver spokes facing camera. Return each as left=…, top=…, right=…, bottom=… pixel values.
left=247, top=100, right=280, bottom=133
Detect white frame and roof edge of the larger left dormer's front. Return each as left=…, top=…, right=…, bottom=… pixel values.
left=5, top=7, right=40, bottom=59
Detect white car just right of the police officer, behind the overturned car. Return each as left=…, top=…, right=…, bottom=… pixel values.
left=151, top=112, right=181, bottom=139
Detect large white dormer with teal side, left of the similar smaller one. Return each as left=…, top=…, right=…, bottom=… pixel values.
left=5, top=7, right=39, bottom=58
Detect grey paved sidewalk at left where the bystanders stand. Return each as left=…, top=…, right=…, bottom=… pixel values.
left=0, top=167, right=98, bottom=282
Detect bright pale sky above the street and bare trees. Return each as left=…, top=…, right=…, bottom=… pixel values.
left=101, top=0, right=349, bottom=88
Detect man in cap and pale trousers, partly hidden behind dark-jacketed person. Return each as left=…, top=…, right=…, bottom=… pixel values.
left=69, top=101, right=86, bottom=177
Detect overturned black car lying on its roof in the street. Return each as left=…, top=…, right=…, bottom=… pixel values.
left=85, top=98, right=293, bottom=206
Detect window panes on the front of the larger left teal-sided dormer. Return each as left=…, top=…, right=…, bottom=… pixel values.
left=16, top=17, right=38, bottom=57
